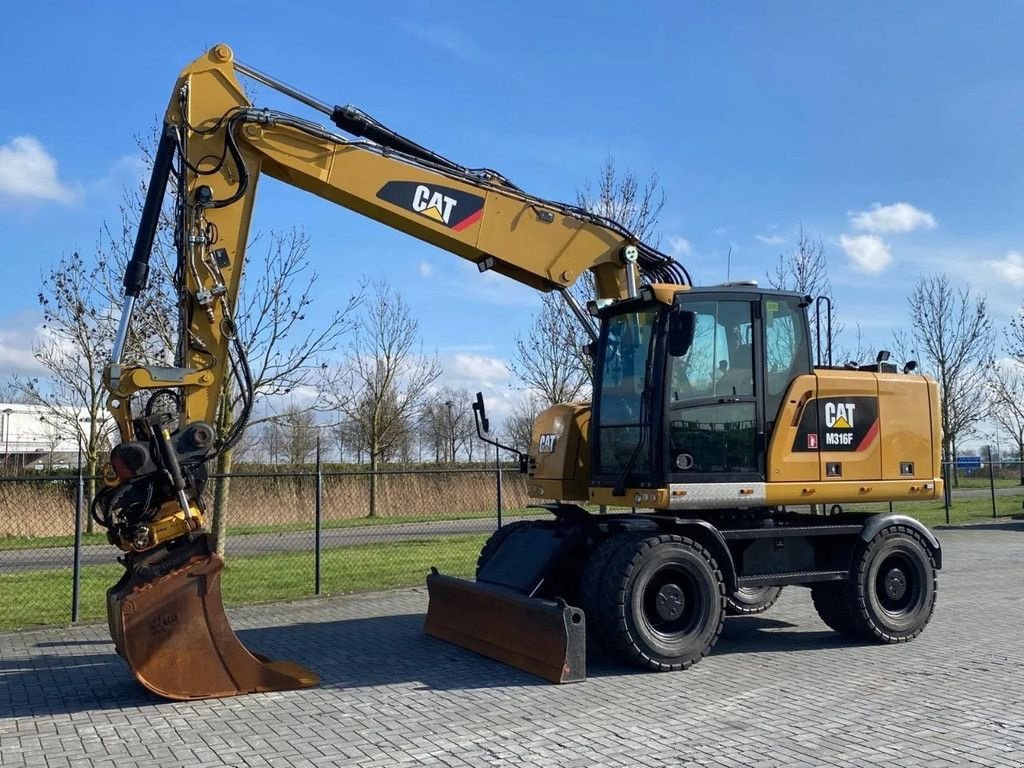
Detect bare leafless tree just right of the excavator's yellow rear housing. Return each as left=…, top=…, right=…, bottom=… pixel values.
left=896, top=274, right=995, bottom=481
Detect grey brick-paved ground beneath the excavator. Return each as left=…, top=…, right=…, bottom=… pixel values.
left=0, top=523, right=1024, bottom=768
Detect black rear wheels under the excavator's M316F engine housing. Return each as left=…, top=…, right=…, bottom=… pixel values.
left=811, top=525, right=939, bottom=643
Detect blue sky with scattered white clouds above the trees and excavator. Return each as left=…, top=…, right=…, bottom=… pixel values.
left=0, top=1, right=1024, bottom=428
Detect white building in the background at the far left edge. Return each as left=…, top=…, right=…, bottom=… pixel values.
left=0, top=402, right=89, bottom=471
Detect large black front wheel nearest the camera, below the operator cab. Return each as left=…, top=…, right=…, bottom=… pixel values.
left=596, top=535, right=725, bottom=672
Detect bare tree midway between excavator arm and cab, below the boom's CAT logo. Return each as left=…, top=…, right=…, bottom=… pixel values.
left=322, top=281, right=441, bottom=517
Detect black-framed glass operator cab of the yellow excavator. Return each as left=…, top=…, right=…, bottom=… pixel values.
left=591, top=286, right=812, bottom=487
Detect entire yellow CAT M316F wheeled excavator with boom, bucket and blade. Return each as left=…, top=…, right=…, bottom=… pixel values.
left=99, top=45, right=942, bottom=698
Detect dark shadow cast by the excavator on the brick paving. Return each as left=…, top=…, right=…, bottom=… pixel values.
left=0, top=613, right=880, bottom=718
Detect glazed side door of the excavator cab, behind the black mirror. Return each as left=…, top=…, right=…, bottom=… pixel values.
left=664, top=293, right=765, bottom=483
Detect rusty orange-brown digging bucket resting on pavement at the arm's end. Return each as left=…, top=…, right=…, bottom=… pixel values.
left=106, top=536, right=319, bottom=699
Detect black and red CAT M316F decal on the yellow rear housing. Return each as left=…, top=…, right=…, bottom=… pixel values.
left=793, top=396, right=879, bottom=452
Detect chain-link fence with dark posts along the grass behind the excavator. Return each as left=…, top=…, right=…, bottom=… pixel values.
left=0, top=461, right=1024, bottom=629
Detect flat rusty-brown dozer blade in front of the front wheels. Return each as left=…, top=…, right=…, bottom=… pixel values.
left=423, top=572, right=587, bottom=683
